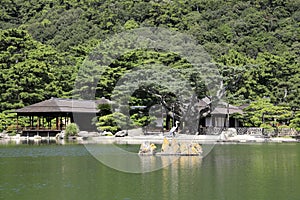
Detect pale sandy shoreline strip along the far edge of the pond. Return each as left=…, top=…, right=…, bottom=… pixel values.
left=0, top=134, right=300, bottom=145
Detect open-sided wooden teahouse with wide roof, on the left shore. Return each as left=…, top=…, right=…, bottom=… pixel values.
left=15, top=97, right=110, bottom=136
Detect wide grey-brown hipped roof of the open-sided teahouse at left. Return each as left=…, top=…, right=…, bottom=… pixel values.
left=15, top=97, right=110, bottom=114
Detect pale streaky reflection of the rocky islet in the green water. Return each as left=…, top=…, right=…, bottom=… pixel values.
left=138, top=156, right=202, bottom=200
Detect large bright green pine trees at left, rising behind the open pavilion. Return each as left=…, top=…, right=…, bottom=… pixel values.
left=0, top=29, right=75, bottom=112
